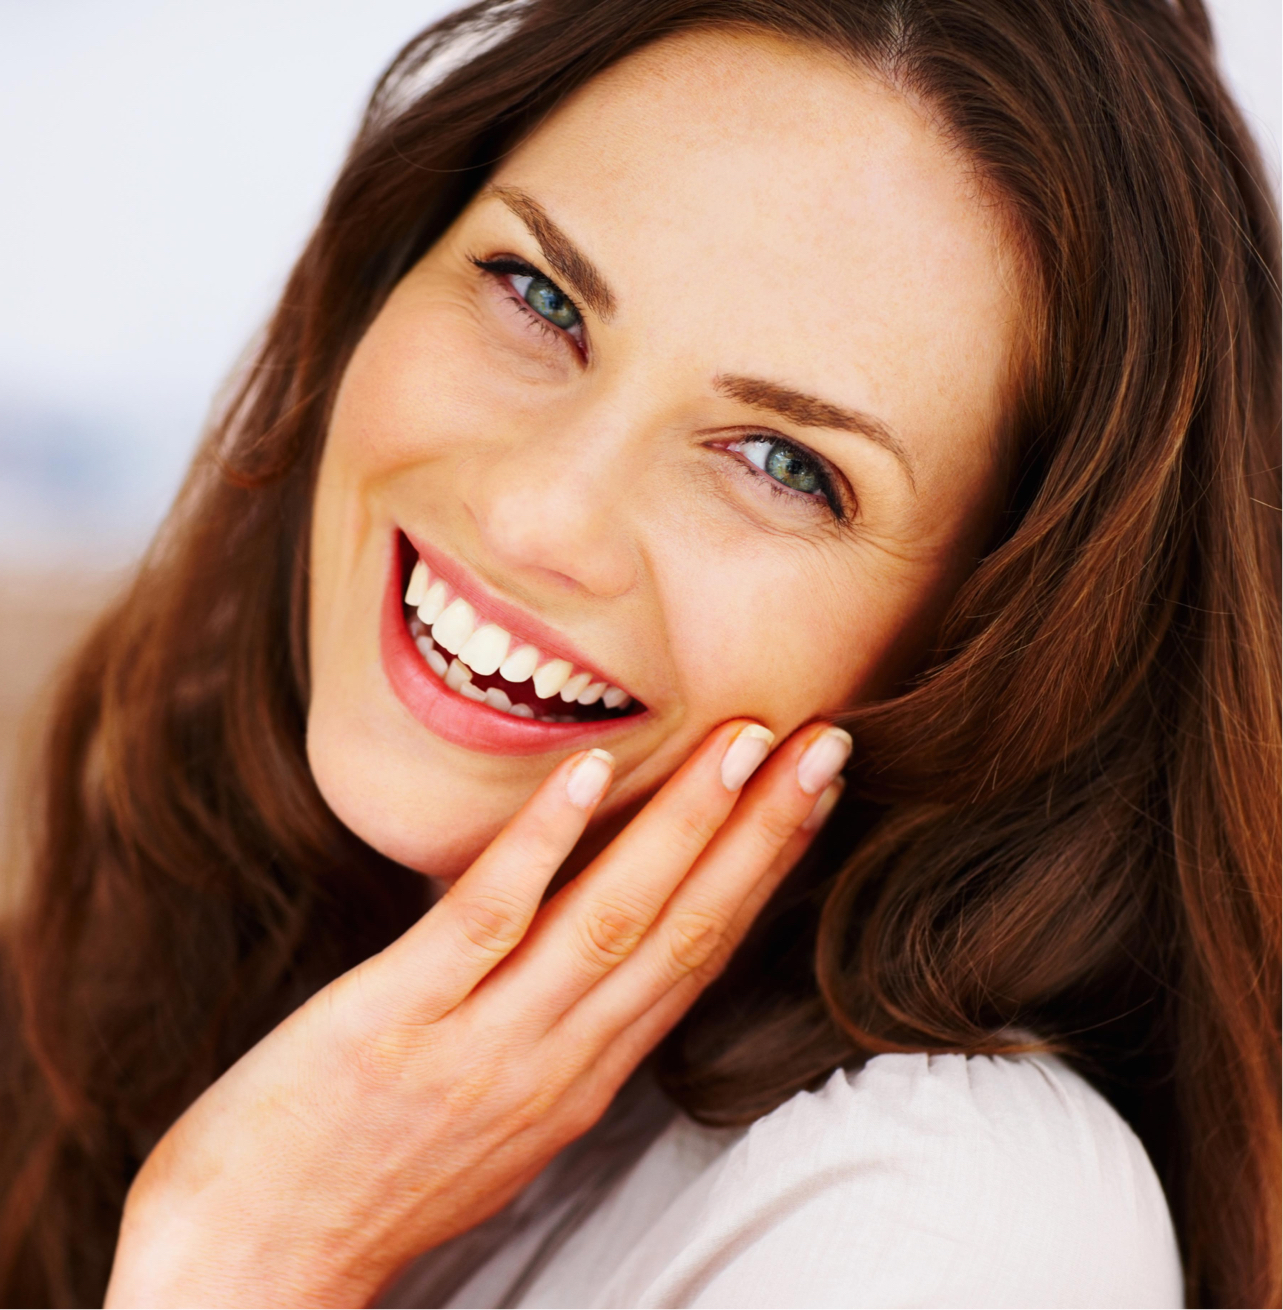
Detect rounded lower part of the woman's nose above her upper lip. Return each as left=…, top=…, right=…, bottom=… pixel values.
left=463, top=406, right=640, bottom=599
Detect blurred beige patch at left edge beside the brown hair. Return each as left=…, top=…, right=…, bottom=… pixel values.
left=0, top=570, right=121, bottom=912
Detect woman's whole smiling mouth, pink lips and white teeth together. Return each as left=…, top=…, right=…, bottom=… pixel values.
left=381, top=533, right=645, bottom=755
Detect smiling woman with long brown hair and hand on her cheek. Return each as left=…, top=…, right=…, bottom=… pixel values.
left=0, top=0, right=1279, bottom=1305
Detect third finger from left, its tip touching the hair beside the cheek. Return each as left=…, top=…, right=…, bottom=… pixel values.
left=560, top=726, right=851, bottom=1043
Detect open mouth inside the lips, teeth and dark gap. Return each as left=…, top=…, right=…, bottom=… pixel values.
left=397, top=533, right=646, bottom=726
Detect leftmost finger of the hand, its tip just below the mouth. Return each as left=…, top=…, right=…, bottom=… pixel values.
left=383, top=749, right=615, bottom=1023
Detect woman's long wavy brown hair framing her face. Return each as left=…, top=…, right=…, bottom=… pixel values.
left=0, top=0, right=1280, bottom=1305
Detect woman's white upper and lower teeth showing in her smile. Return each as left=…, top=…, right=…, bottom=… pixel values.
left=405, top=559, right=629, bottom=718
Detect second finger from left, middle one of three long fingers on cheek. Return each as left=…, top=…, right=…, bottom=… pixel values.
left=493, top=719, right=775, bottom=1011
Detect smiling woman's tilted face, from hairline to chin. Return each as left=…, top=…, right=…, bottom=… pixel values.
left=308, top=34, right=1020, bottom=878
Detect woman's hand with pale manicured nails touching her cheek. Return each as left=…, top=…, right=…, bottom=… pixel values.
left=107, top=721, right=849, bottom=1306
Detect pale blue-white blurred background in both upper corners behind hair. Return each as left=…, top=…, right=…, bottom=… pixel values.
left=0, top=0, right=1283, bottom=567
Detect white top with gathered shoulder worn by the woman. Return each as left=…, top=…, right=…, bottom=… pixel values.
left=393, top=1055, right=1183, bottom=1307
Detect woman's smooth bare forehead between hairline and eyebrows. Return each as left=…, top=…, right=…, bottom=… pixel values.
left=499, top=33, right=1018, bottom=476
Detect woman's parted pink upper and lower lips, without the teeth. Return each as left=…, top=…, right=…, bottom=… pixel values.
left=379, top=533, right=650, bottom=755
